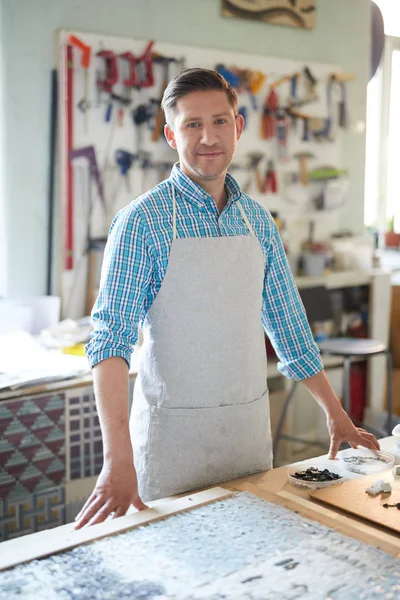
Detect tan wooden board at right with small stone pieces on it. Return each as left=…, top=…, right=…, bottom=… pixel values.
left=310, top=469, right=400, bottom=533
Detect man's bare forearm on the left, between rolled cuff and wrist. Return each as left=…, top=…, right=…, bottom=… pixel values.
left=93, top=357, right=133, bottom=462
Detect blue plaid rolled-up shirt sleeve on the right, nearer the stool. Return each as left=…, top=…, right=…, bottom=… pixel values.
left=262, top=220, right=323, bottom=381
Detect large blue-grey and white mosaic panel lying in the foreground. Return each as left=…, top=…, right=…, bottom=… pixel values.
left=0, top=493, right=400, bottom=600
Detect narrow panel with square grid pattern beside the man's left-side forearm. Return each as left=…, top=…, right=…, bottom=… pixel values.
left=67, top=387, right=103, bottom=480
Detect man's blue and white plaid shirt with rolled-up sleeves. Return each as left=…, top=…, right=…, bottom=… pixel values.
left=86, top=166, right=323, bottom=380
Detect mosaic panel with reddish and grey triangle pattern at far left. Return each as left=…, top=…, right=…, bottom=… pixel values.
left=0, top=394, right=65, bottom=503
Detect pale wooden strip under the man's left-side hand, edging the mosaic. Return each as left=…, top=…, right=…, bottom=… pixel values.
left=0, top=487, right=235, bottom=571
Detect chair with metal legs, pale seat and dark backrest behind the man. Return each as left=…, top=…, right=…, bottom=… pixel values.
left=273, top=286, right=393, bottom=456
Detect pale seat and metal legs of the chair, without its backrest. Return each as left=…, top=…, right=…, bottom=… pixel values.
left=273, top=338, right=392, bottom=456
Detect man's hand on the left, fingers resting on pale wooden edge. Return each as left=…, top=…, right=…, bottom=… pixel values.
left=75, top=462, right=148, bottom=529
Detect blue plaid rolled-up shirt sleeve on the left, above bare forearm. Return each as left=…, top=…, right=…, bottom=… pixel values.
left=85, top=205, right=153, bottom=368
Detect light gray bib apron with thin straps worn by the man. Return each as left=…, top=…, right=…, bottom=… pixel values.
left=130, top=182, right=272, bottom=502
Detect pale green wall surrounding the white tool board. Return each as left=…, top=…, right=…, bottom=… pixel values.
left=0, top=0, right=370, bottom=296
